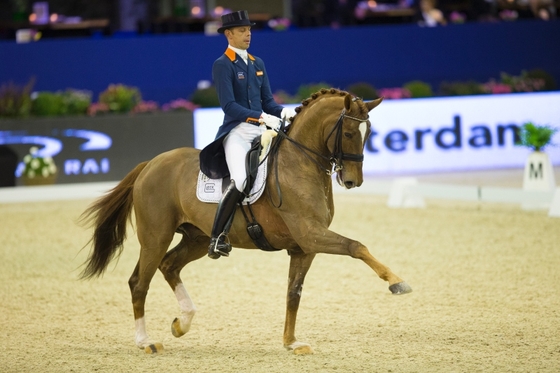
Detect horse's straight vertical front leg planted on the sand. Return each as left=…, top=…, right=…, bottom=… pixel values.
left=283, top=252, right=315, bottom=355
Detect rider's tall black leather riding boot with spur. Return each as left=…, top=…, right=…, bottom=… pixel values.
left=208, top=180, right=242, bottom=259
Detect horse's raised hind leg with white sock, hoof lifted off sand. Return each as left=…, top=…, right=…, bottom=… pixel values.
left=159, top=226, right=209, bottom=338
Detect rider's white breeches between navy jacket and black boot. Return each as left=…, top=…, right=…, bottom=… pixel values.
left=223, top=122, right=266, bottom=192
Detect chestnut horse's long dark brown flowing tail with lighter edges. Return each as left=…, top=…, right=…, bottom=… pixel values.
left=79, top=162, right=148, bottom=279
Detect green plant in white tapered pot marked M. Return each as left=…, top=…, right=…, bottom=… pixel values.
left=516, top=122, right=558, bottom=208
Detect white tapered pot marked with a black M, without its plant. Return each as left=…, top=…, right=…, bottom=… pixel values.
left=521, top=151, right=556, bottom=210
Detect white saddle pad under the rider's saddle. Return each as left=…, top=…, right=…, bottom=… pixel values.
left=196, top=134, right=276, bottom=205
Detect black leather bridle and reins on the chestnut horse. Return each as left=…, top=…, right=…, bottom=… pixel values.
left=268, top=109, right=369, bottom=208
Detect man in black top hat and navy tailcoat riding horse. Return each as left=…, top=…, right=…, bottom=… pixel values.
left=200, top=11, right=296, bottom=259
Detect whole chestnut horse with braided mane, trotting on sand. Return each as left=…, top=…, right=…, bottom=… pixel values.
left=81, top=88, right=412, bottom=354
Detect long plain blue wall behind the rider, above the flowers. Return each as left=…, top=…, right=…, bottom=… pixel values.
left=0, top=20, right=560, bottom=103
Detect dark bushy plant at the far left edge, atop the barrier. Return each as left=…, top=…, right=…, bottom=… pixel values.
left=0, top=78, right=35, bottom=118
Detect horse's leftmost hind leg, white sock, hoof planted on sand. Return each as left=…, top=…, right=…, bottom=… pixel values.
left=128, top=227, right=173, bottom=353
